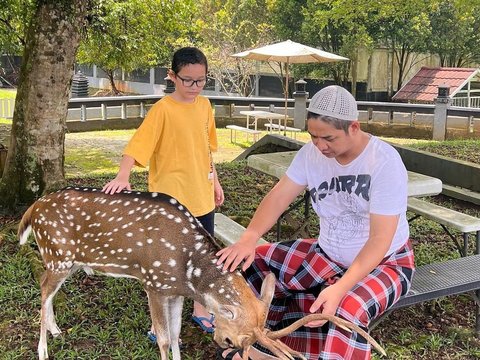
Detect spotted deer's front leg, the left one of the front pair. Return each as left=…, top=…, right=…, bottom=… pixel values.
left=147, top=290, right=171, bottom=360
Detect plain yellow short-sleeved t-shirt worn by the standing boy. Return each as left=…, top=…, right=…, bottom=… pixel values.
left=123, top=96, right=217, bottom=216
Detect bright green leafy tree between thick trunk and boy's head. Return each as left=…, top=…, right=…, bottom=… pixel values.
left=78, top=0, right=193, bottom=94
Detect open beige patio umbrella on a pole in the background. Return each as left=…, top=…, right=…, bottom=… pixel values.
left=232, top=40, right=349, bottom=134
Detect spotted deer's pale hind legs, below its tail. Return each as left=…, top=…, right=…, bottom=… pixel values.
left=38, top=270, right=70, bottom=360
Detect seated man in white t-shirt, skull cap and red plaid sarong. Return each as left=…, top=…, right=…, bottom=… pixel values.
left=217, top=86, right=414, bottom=359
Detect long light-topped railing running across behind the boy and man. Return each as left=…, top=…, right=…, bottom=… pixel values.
left=0, top=95, right=480, bottom=132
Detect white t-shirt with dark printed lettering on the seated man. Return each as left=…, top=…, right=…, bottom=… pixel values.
left=286, top=136, right=409, bottom=266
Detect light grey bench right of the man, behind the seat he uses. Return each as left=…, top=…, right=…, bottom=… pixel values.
left=408, top=197, right=480, bottom=256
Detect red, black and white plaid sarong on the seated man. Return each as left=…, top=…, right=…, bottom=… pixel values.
left=245, top=239, right=414, bottom=360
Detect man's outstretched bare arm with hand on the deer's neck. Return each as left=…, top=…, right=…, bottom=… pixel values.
left=216, top=175, right=305, bottom=271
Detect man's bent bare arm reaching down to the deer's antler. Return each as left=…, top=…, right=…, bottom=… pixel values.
left=308, top=214, right=399, bottom=327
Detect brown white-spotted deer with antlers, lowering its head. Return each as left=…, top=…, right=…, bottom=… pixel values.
left=18, top=187, right=383, bottom=360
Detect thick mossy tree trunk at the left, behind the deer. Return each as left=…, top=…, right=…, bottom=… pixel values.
left=0, top=0, right=90, bottom=209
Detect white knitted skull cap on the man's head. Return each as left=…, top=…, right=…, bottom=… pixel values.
left=307, top=85, right=358, bottom=121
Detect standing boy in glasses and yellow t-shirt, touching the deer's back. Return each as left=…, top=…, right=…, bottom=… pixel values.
left=102, top=47, right=224, bottom=333
